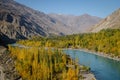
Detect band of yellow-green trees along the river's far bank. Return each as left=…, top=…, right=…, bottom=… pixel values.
left=18, top=29, right=120, bottom=58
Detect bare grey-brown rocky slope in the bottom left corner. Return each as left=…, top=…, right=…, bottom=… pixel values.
left=0, top=46, right=22, bottom=80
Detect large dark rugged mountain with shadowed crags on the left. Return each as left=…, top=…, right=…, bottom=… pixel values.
left=0, top=0, right=72, bottom=39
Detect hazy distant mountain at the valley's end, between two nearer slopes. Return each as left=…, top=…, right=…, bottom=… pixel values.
left=48, top=13, right=101, bottom=33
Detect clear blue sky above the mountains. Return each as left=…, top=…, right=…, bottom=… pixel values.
left=15, top=0, right=120, bottom=18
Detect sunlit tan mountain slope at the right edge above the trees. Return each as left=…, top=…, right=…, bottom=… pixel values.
left=89, top=9, right=120, bottom=32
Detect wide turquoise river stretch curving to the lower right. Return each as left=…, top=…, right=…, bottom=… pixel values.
left=64, top=49, right=120, bottom=80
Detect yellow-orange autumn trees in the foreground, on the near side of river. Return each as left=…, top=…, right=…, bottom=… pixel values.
left=9, top=46, right=90, bottom=80
